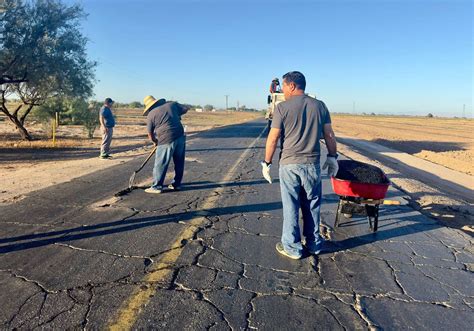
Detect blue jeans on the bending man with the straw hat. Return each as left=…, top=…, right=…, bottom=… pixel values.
left=152, top=136, right=186, bottom=188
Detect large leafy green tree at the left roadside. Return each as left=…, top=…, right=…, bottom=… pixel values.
left=0, top=0, right=96, bottom=140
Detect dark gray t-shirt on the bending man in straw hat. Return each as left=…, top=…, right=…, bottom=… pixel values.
left=146, top=102, right=186, bottom=145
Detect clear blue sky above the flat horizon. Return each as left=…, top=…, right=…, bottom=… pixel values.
left=66, top=0, right=473, bottom=117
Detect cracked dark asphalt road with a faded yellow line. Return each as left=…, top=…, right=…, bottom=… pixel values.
left=0, top=121, right=474, bottom=330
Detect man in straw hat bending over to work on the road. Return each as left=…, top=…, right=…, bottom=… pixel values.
left=143, top=95, right=188, bottom=194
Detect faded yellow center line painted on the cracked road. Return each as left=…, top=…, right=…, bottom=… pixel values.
left=109, top=129, right=265, bottom=330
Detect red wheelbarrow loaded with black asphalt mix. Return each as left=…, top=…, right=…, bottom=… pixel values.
left=331, top=160, right=400, bottom=232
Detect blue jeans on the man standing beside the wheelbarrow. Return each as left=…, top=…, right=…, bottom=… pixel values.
left=279, top=162, right=322, bottom=255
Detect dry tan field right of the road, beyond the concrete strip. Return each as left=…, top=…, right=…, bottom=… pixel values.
left=332, top=114, right=474, bottom=175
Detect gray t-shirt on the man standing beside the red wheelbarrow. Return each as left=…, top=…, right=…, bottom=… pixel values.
left=272, top=95, right=331, bottom=164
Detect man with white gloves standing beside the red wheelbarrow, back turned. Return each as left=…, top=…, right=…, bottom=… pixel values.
left=262, top=71, right=338, bottom=259
